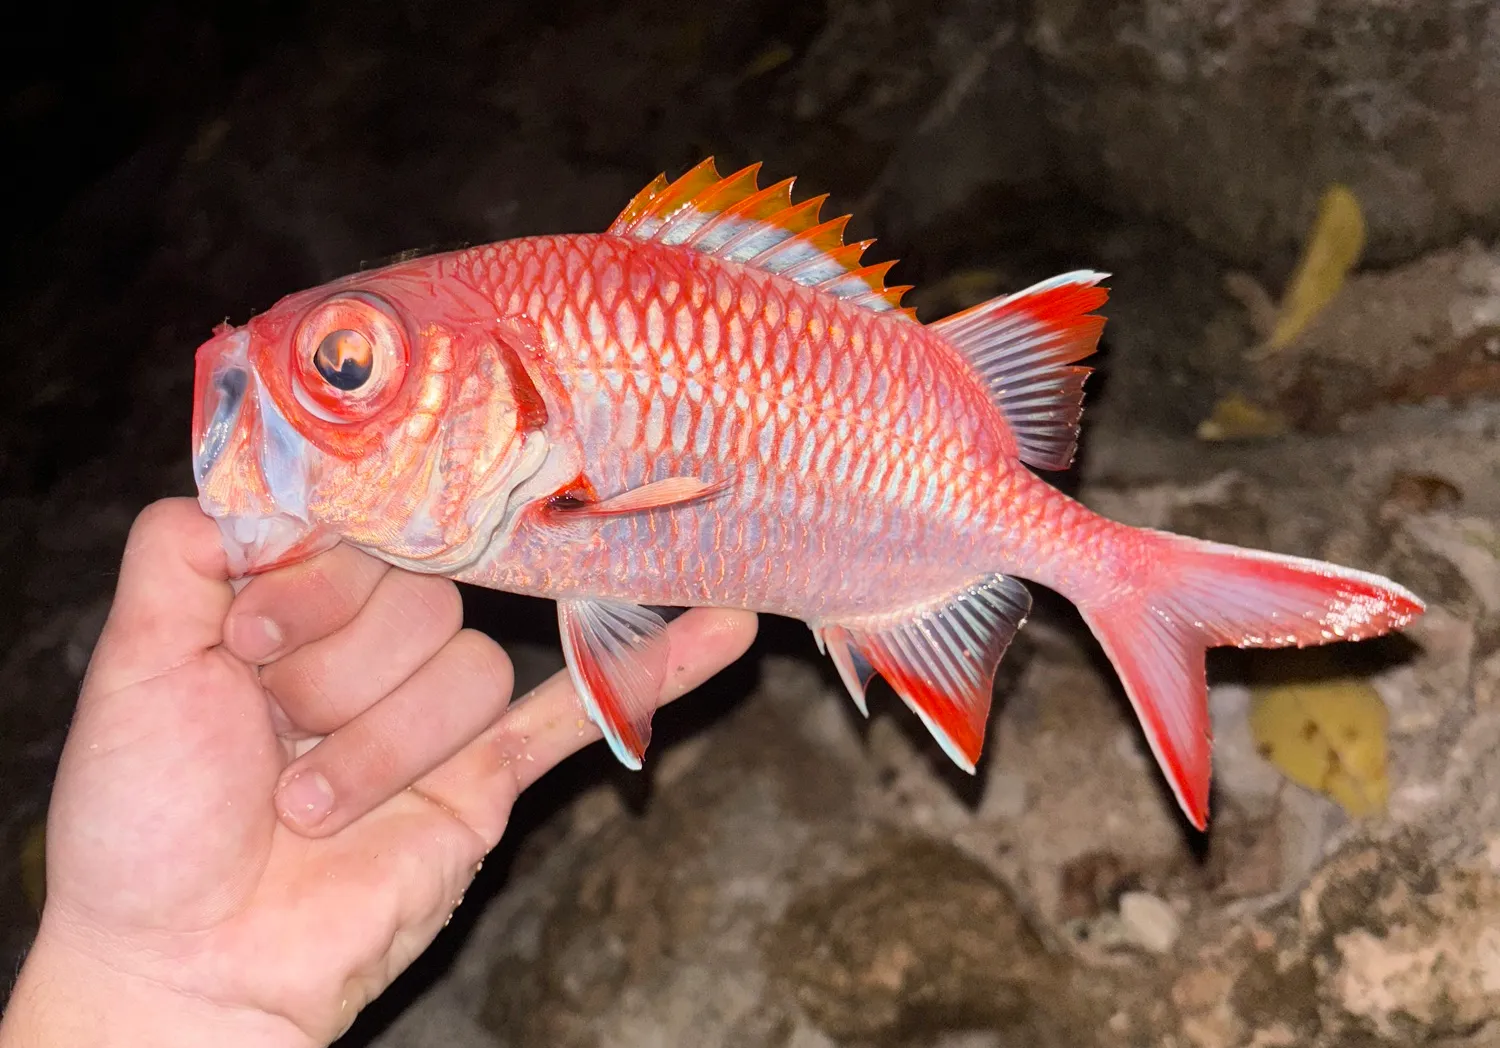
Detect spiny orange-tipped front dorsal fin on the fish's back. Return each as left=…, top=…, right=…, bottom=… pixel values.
left=609, top=157, right=917, bottom=319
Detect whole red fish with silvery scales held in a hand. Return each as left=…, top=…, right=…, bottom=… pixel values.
left=194, top=160, right=1424, bottom=828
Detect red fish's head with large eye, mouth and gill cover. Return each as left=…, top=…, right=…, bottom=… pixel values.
left=192, top=256, right=548, bottom=576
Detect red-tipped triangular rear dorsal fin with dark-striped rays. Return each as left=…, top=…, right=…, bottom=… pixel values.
left=932, top=270, right=1109, bottom=469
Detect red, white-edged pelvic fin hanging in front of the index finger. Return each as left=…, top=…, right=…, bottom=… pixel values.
left=558, top=600, right=668, bottom=771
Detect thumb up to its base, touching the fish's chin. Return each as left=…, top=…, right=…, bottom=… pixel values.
left=81, top=498, right=234, bottom=702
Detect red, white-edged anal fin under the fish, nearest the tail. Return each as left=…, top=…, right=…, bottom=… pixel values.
left=818, top=576, right=1031, bottom=774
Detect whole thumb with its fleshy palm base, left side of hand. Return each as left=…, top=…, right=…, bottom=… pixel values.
left=47, top=499, right=282, bottom=930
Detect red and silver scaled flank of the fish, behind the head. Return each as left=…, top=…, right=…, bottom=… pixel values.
left=450, top=234, right=1091, bottom=622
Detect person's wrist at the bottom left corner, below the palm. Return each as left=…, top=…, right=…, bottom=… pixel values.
left=0, top=922, right=318, bottom=1048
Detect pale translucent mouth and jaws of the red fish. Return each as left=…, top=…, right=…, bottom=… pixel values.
left=192, top=331, right=338, bottom=577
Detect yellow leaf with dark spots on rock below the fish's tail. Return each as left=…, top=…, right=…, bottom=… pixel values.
left=1250, top=678, right=1391, bottom=817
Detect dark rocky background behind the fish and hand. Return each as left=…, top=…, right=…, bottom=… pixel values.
left=0, top=0, right=1500, bottom=1048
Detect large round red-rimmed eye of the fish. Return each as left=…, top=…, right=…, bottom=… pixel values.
left=293, top=291, right=408, bottom=423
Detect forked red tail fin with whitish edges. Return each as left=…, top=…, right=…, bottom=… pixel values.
left=1074, top=525, right=1424, bottom=829
